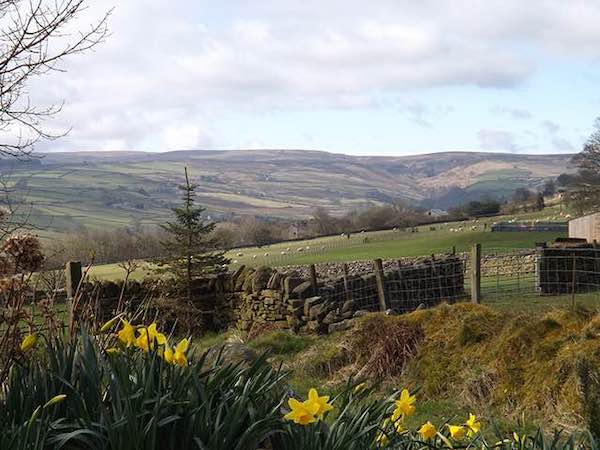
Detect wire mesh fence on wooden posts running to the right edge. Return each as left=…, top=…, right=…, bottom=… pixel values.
left=308, top=245, right=600, bottom=313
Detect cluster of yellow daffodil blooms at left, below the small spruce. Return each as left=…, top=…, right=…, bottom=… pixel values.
left=100, top=316, right=189, bottom=367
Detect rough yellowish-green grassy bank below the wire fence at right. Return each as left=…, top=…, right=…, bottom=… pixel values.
left=224, top=304, right=600, bottom=429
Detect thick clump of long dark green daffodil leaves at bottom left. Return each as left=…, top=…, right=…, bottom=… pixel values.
left=0, top=335, right=285, bottom=450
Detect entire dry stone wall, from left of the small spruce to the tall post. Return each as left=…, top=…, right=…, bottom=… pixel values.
left=69, top=255, right=464, bottom=333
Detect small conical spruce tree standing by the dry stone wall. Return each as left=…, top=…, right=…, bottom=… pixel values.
left=158, top=167, right=229, bottom=301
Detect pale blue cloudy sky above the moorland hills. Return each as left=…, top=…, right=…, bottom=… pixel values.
left=29, top=0, right=600, bottom=155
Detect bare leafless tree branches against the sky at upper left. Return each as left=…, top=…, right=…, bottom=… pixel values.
left=0, top=0, right=110, bottom=158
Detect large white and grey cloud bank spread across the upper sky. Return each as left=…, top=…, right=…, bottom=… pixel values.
left=16, top=0, right=600, bottom=151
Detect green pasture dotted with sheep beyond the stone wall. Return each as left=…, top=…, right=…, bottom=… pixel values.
left=90, top=207, right=560, bottom=279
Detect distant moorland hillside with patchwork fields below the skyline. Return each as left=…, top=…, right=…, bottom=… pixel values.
left=0, top=150, right=571, bottom=236
